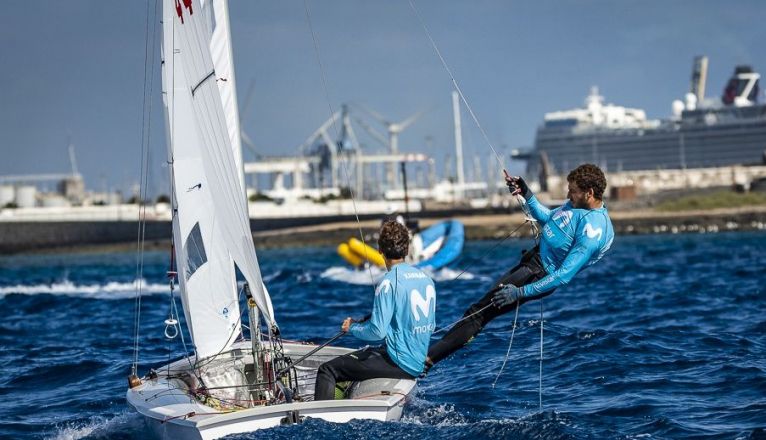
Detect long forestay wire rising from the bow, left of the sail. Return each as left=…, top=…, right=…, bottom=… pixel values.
left=131, top=0, right=158, bottom=375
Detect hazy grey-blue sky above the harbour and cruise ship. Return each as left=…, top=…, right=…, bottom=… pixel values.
left=0, top=0, right=766, bottom=193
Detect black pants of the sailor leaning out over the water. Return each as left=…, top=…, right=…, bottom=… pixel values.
left=428, top=247, right=553, bottom=364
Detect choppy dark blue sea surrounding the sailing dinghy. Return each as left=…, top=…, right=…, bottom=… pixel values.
left=0, top=232, right=766, bottom=440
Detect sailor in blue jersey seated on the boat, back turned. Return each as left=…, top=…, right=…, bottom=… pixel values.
left=314, top=221, right=436, bottom=400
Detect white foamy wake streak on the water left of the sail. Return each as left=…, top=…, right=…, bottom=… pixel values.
left=0, top=280, right=168, bottom=299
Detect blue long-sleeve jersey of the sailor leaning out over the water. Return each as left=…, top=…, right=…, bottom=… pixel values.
left=522, top=196, right=614, bottom=296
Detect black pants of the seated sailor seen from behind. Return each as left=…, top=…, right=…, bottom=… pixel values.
left=314, top=347, right=414, bottom=400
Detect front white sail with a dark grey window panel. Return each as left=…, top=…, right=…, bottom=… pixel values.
left=163, top=0, right=275, bottom=357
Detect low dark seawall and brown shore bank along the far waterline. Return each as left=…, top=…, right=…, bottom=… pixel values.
left=0, top=207, right=766, bottom=254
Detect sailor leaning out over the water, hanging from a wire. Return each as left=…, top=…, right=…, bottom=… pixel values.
left=426, top=164, right=614, bottom=369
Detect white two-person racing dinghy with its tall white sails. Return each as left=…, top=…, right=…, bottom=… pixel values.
left=126, top=0, right=416, bottom=439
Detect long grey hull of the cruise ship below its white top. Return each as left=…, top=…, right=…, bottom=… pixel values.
left=535, top=105, right=766, bottom=172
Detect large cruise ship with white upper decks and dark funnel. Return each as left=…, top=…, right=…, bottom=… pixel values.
left=530, top=57, right=766, bottom=176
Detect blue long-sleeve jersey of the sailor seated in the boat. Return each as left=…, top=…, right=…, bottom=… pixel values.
left=349, top=263, right=436, bottom=376
